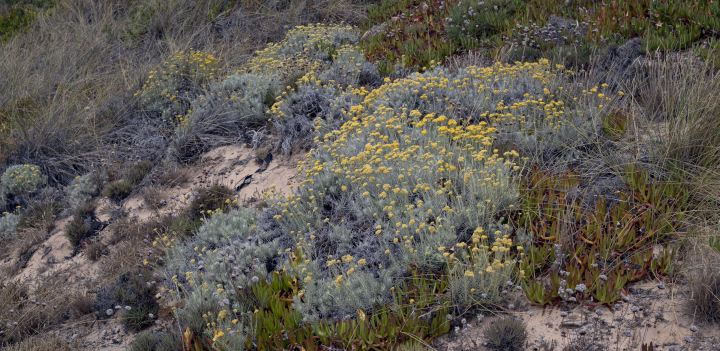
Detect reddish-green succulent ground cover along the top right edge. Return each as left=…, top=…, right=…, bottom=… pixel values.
left=362, top=0, right=720, bottom=69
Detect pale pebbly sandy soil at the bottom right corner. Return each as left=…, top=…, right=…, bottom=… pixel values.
left=432, top=281, right=720, bottom=351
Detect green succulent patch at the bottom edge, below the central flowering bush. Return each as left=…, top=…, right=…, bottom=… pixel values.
left=246, top=271, right=450, bottom=350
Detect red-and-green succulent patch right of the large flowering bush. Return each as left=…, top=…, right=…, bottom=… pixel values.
left=516, top=165, right=688, bottom=305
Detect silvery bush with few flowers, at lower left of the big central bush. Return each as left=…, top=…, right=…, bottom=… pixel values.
left=166, top=208, right=281, bottom=349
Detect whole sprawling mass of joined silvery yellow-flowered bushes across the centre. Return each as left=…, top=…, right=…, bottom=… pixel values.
left=163, top=22, right=620, bottom=342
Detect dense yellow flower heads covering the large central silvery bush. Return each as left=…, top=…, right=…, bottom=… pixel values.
left=273, top=62, right=532, bottom=286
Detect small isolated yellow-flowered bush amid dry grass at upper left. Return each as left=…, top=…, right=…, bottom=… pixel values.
left=135, top=49, right=219, bottom=123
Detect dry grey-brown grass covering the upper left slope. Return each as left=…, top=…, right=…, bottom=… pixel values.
left=0, top=0, right=369, bottom=184
